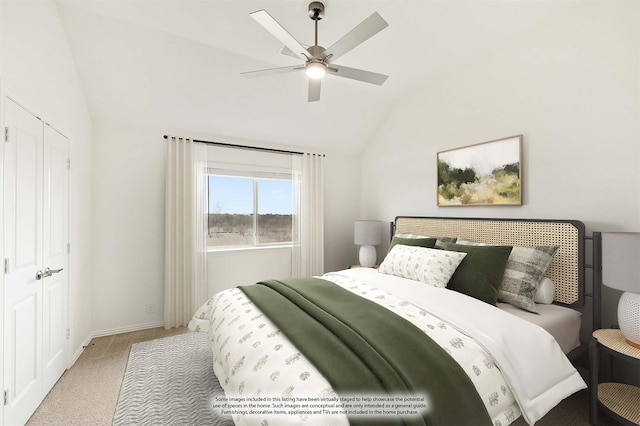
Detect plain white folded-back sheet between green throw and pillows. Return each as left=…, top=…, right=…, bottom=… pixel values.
left=341, top=268, right=587, bottom=424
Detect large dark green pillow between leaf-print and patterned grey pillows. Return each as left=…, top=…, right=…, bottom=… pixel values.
left=444, top=243, right=513, bottom=305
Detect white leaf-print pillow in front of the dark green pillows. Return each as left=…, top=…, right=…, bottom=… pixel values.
left=378, top=244, right=467, bottom=288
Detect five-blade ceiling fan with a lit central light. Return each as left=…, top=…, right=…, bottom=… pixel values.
left=242, top=1, right=389, bottom=102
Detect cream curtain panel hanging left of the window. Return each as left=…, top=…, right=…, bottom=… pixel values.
left=164, top=137, right=206, bottom=329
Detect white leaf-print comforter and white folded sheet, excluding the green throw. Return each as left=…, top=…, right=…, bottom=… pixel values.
left=198, top=268, right=586, bottom=425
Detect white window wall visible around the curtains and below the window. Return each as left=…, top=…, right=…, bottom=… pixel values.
left=92, top=119, right=359, bottom=335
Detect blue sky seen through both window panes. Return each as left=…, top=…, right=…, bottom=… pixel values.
left=209, top=176, right=293, bottom=214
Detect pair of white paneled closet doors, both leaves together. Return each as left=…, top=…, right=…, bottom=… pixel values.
left=3, top=98, right=68, bottom=425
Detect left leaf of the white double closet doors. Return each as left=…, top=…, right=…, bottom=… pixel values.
left=3, top=99, right=43, bottom=425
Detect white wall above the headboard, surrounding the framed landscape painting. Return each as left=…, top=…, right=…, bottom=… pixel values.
left=361, top=2, right=640, bottom=326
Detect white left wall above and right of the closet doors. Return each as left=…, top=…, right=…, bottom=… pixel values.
left=0, top=1, right=92, bottom=362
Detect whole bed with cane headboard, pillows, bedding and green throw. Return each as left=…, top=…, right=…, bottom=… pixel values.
left=190, top=216, right=586, bottom=426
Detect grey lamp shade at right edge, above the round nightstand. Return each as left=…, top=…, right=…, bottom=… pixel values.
left=602, top=232, right=640, bottom=293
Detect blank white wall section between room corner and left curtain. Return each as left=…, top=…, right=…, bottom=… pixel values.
left=91, top=120, right=165, bottom=335
